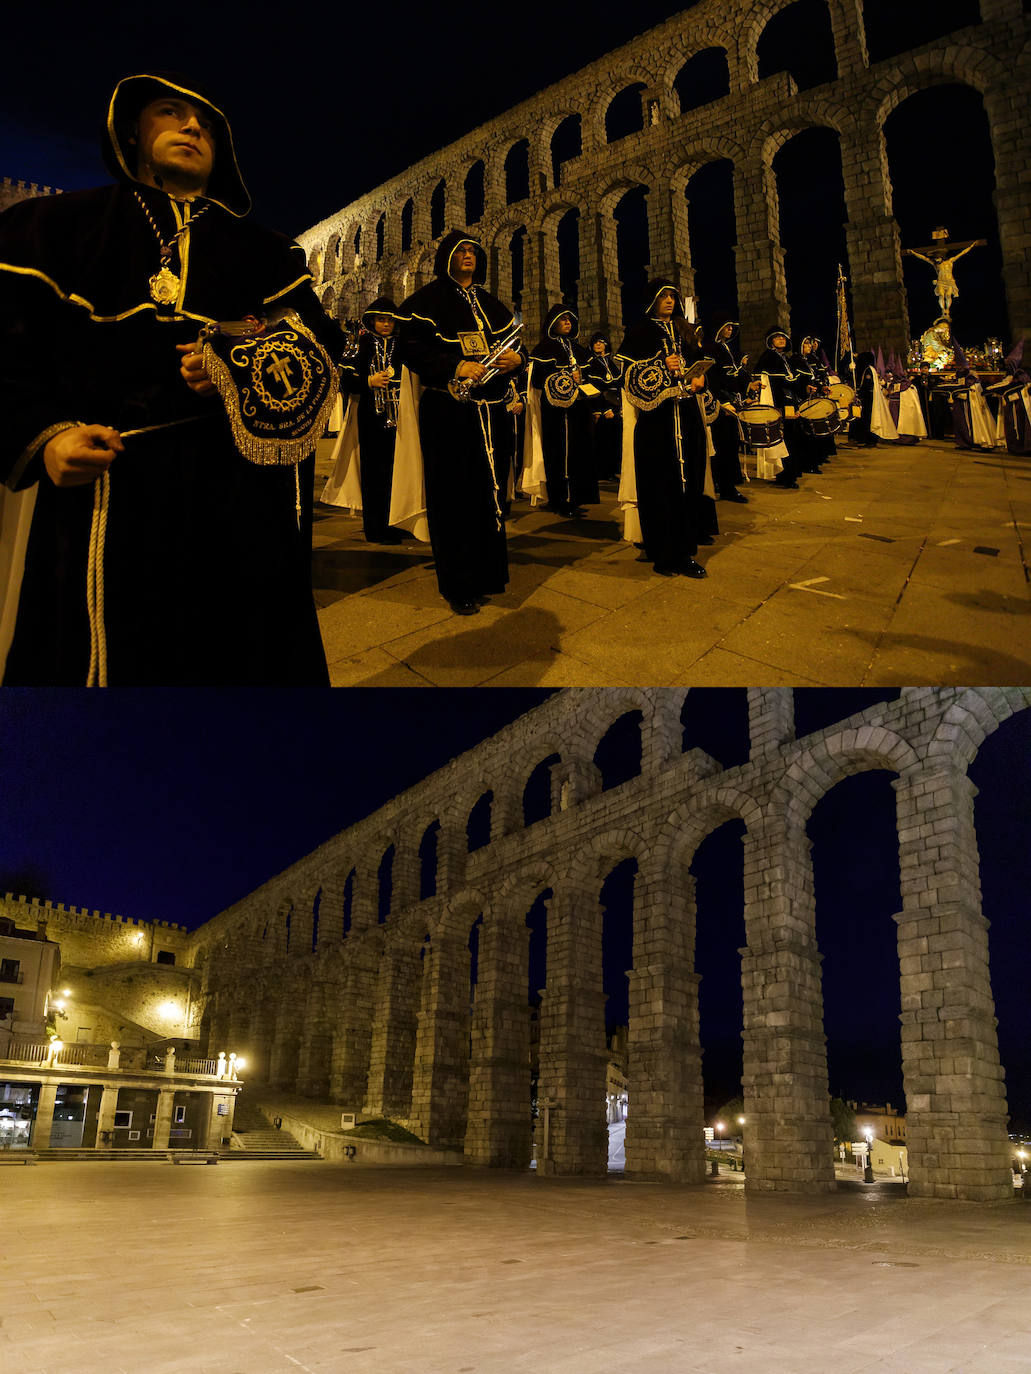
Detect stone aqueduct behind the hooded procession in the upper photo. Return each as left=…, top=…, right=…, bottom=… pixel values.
left=300, top=0, right=1031, bottom=354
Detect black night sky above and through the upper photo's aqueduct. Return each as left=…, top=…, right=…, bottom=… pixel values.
left=0, top=0, right=1012, bottom=350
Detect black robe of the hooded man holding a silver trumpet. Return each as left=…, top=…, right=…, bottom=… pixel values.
left=401, top=250, right=521, bottom=602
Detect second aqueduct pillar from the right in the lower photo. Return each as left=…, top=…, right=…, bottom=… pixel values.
left=741, top=815, right=834, bottom=1193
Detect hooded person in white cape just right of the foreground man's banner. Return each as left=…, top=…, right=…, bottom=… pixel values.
left=322, top=295, right=404, bottom=544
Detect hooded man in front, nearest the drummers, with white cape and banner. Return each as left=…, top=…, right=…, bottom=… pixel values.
left=619, top=279, right=718, bottom=578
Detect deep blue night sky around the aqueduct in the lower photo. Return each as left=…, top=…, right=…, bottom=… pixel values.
left=0, top=688, right=1031, bottom=1128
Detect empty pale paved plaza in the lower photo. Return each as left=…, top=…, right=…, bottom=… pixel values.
left=0, top=1161, right=1031, bottom=1374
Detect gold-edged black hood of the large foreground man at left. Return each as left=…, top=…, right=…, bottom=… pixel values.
left=102, top=71, right=250, bottom=217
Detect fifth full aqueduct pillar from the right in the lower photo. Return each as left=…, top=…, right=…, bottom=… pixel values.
left=466, top=912, right=532, bottom=1169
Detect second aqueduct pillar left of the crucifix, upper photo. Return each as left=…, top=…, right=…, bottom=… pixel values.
left=734, top=158, right=788, bottom=359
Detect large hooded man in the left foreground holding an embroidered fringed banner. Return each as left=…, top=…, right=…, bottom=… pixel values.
left=0, top=74, right=344, bottom=686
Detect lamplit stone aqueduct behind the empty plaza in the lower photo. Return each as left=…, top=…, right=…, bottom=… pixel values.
left=190, top=687, right=1031, bottom=1200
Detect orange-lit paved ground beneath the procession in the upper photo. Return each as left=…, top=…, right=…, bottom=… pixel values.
left=315, top=441, right=1031, bottom=687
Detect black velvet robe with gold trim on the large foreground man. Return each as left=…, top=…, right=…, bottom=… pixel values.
left=0, top=184, right=341, bottom=686
